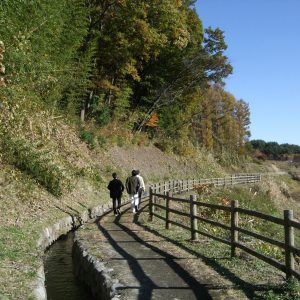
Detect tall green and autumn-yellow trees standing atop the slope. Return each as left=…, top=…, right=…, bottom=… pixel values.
left=0, top=0, right=250, bottom=159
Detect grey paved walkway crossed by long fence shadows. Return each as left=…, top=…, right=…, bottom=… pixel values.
left=81, top=203, right=246, bottom=300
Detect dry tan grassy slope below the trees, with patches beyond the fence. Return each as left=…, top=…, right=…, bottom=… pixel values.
left=0, top=118, right=298, bottom=299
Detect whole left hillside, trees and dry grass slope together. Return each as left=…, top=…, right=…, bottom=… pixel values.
left=0, top=0, right=300, bottom=299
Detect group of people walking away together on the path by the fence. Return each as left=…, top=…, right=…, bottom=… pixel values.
left=107, top=170, right=145, bottom=216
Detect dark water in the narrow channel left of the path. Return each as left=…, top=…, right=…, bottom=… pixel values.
left=44, top=232, right=94, bottom=300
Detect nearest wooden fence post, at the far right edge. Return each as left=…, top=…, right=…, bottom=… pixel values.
left=284, top=210, right=295, bottom=279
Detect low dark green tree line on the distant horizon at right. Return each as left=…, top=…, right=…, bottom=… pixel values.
left=250, top=140, right=300, bottom=159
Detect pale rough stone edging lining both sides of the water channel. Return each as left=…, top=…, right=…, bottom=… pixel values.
left=31, top=204, right=116, bottom=300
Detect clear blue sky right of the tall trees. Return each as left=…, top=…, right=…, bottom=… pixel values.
left=196, top=0, right=300, bottom=145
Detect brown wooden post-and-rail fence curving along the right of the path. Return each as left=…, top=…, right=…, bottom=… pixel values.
left=149, top=174, right=300, bottom=279
